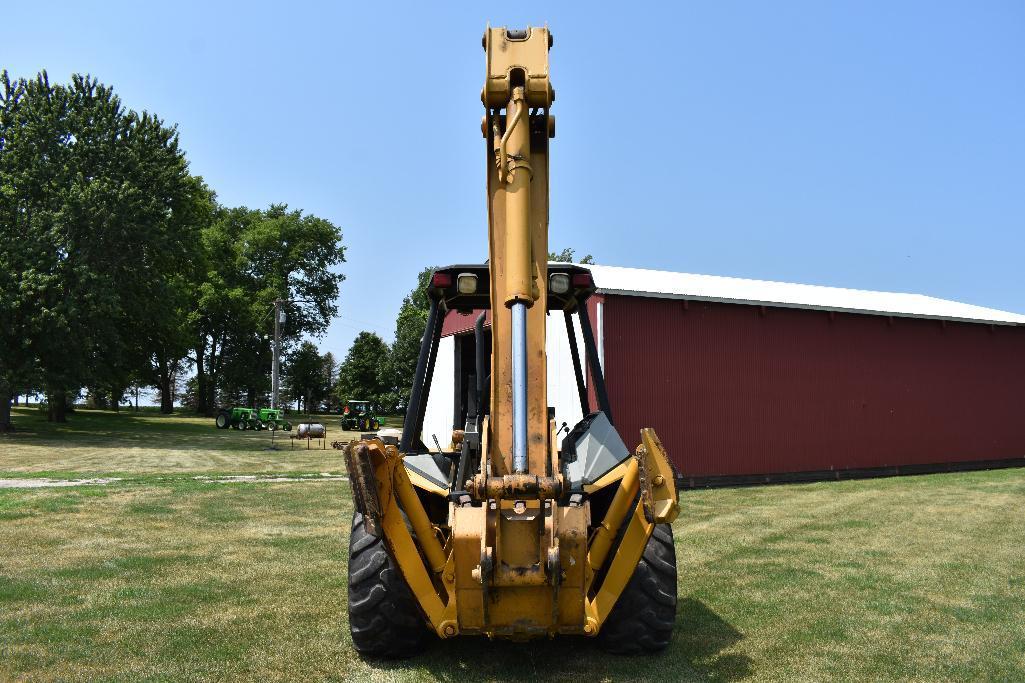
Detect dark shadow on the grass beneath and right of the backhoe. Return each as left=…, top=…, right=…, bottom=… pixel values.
left=366, top=599, right=752, bottom=682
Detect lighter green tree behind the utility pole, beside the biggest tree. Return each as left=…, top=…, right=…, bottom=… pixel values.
left=187, top=204, right=345, bottom=414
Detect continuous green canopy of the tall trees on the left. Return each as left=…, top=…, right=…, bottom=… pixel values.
left=0, top=71, right=344, bottom=420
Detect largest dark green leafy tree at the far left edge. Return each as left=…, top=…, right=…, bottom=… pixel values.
left=0, top=72, right=202, bottom=420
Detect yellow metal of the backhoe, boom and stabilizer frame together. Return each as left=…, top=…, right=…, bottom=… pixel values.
left=340, top=28, right=679, bottom=639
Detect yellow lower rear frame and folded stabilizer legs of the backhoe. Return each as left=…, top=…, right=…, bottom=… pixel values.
left=346, top=430, right=677, bottom=639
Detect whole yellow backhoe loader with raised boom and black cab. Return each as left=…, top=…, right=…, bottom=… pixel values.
left=337, top=28, right=679, bottom=657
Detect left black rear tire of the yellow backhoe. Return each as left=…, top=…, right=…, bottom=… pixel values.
left=349, top=512, right=431, bottom=659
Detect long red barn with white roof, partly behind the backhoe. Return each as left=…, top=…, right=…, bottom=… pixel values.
left=424, top=266, right=1025, bottom=486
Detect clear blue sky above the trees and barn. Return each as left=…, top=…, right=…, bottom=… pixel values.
left=0, top=0, right=1025, bottom=355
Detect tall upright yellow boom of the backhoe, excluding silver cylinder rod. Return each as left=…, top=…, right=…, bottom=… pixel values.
left=482, top=28, right=554, bottom=475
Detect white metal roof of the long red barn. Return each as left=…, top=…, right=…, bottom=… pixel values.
left=586, top=260, right=1025, bottom=325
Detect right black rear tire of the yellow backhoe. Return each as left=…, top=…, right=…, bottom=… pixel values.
left=598, top=524, right=677, bottom=654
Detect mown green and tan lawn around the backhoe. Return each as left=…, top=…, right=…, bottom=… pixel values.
left=0, top=412, right=1025, bottom=681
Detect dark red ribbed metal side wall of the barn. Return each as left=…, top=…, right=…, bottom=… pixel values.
left=591, top=294, right=1025, bottom=477
